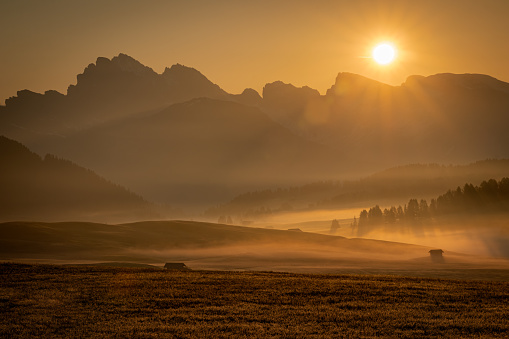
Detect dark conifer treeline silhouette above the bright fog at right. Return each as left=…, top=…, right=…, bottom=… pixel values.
left=353, top=178, right=509, bottom=228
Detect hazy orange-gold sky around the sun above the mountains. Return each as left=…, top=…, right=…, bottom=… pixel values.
left=0, top=0, right=509, bottom=104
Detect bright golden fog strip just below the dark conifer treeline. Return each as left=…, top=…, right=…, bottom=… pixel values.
left=249, top=209, right=509, bottom=258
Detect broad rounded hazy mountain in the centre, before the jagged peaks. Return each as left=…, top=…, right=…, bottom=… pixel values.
left=51, top=98, right=343, bottom=206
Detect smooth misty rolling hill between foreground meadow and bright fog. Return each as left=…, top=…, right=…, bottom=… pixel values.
left=0, top=221, right=509, bottom=280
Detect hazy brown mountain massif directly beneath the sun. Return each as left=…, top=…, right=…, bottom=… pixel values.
left=263, top=73, right=509, bottom=168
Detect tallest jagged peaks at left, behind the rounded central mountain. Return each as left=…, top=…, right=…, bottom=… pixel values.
left=0, top=54, right=228, bottom=153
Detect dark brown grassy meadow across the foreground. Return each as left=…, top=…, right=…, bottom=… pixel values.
left=0, top=263, right=509, bottom=338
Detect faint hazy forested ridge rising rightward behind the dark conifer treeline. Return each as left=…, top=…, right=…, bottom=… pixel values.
left=206, top=159, right=509, bottom=219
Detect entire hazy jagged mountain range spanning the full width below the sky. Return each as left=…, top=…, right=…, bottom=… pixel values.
left=0, top=54, right=509, bottom=212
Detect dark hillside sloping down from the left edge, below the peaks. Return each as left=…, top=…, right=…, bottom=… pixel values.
left=0, top=136, right=156, bottom=221
